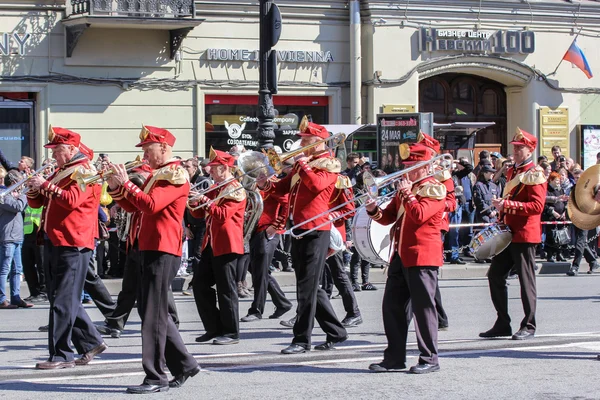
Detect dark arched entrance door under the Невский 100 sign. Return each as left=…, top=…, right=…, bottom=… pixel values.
left=419, top=73, right=508, bottom=155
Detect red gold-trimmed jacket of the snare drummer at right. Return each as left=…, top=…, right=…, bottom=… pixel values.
left=503, top=160, right=547, bottom=243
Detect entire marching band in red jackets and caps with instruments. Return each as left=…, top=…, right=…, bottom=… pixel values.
left=17, top=115, right=600, bottom=394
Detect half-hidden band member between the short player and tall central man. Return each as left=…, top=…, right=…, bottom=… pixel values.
left=241, top=167, right=292, bottom=322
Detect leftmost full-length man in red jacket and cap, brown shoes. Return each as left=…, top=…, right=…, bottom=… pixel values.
left=27, top=127, right=107, bottom=369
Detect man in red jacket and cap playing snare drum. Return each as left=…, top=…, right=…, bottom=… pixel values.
left=479, top=128, right=546, bottom=340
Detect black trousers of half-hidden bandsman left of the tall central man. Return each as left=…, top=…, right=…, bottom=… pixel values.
left=248, top=231, right=292, bottom=315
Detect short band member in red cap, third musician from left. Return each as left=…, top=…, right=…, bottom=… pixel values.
left=188, top=149, right=246, bottom=345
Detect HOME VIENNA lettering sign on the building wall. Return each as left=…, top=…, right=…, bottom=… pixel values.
left=206, top=49, right=333, bottom=63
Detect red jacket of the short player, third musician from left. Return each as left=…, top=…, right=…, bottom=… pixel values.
left=191, top=181, right=246, bottom=257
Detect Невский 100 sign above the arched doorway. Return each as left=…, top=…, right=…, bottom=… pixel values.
left=419, top=28, right=535, bottom=54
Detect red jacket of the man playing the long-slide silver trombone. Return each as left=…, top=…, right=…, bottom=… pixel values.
left=370, top=178, right=446, bottom=267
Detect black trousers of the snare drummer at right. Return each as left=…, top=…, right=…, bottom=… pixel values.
left=488, top=243, right=537, bottom=332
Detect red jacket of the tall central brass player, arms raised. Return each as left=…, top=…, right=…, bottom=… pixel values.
left=270, top=153, right=341, bottom=231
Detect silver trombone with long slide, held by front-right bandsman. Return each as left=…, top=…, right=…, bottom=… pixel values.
left=284, top=154, right=452, bottom=239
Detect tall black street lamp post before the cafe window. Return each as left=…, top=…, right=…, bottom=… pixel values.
left=257, top=0, right=281, bottom=149
